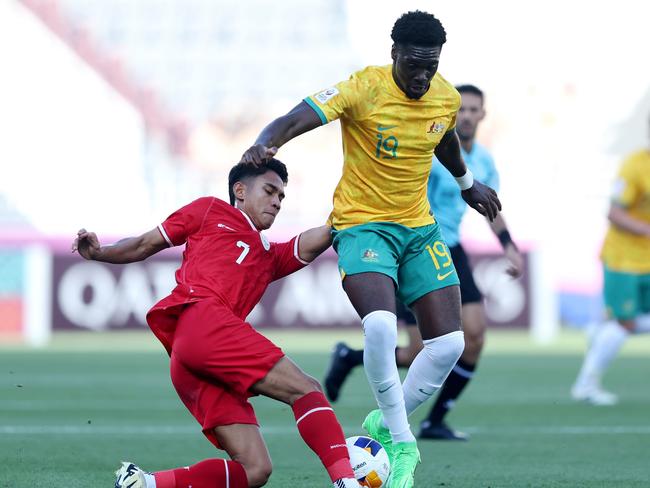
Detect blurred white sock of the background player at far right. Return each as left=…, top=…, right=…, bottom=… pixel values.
left=576, top=320, right=630, bottom=386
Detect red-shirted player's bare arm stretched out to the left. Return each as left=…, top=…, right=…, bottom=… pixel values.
left=72, top=228, right=168, bottom=264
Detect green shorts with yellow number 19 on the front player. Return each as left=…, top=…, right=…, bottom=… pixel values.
left=332, top=222, right=459, bottom=305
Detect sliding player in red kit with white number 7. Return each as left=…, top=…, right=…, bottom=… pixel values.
left=72, top=159, right=359, bottom=488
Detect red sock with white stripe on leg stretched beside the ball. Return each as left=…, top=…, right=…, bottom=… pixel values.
left=292, top=391, right=354, bottom=482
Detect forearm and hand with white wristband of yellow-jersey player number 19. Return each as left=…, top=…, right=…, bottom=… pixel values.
left=435, top=130, right=501, bottom=222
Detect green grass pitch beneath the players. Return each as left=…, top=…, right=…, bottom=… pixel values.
left=0, top=331, right=650, bottom=488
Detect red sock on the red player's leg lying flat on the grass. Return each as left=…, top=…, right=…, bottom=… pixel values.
left=154, top=459, right=248, bottom=488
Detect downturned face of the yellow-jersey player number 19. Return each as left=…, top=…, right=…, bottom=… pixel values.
left=391, top=44, right=442, bottom=100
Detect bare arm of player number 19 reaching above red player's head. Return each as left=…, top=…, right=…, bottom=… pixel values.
left=241, top=101, right=323, bottom=165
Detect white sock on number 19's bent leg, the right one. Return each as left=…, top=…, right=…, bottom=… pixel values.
left=402, top=330, right=465, bottom=415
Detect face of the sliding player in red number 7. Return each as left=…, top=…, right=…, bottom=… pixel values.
left=240, top=170, right=284, bottom=230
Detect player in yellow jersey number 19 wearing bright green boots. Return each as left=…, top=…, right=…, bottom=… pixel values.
left=242, top=11, right=501, bottom=488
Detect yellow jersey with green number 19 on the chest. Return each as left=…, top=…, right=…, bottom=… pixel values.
left=305, top=65, right=461, bottom=230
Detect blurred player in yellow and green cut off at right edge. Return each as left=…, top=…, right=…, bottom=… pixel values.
left=571, top=119, right=650, bottom=405
